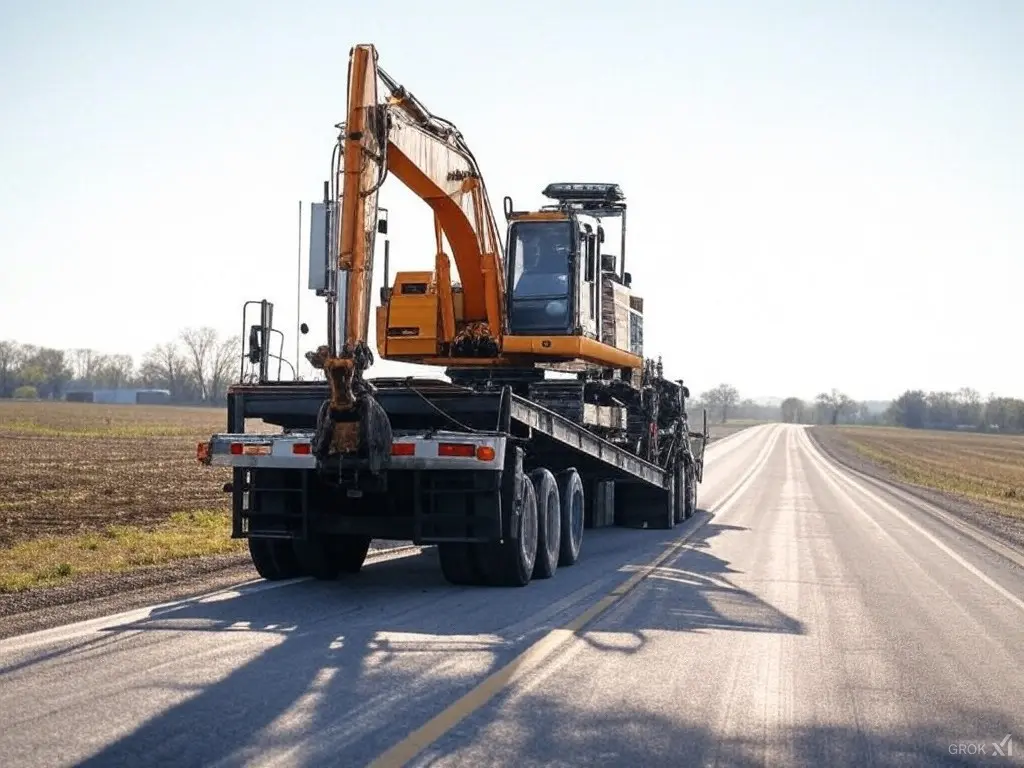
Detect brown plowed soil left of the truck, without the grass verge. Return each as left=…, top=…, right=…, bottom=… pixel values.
left=0, top=401, right=251, bottom=547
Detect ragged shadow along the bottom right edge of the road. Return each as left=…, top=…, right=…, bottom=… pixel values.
left=434, top=685, right=1020, bottom=768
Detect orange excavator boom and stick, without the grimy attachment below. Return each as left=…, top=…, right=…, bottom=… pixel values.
left=338, top=45, right=505, bottom=362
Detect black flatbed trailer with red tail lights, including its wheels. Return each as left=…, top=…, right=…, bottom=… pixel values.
left=201, top=379, right=702, bottom=586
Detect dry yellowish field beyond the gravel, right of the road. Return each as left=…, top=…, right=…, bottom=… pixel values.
left=838, top=427, right=1024, bottom=518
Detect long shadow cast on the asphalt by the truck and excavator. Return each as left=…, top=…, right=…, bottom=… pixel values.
left=59, top=522, right=803, bottom=766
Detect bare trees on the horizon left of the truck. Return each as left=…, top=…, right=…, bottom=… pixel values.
left=0, top=328, right=242, bottom=403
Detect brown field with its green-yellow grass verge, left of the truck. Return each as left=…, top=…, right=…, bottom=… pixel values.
left=0, top=400, right=272, bottom=592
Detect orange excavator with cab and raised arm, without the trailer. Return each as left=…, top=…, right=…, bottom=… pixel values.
left=307, top=45, right=650, bottom=462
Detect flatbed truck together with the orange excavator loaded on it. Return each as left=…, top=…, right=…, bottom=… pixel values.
left=203, top=45, right=708, bottom=586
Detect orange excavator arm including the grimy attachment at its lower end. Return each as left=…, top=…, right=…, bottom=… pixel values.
left=307, top=44, right=505, bottom=462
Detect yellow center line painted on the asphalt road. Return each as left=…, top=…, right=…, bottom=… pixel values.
left=367, top=513, right=711, bottom=768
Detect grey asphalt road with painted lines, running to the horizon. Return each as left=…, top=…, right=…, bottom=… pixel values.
left=0, top=425, right=1024, bottom=768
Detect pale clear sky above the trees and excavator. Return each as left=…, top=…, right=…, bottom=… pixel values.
left=0, top=0, right=1024, bottom=399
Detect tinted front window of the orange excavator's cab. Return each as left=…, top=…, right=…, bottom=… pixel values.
left=508, top=221, right=577, bottom=334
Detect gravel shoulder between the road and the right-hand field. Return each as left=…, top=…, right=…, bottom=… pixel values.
left=807, top=427, right=1024, bottom=551
